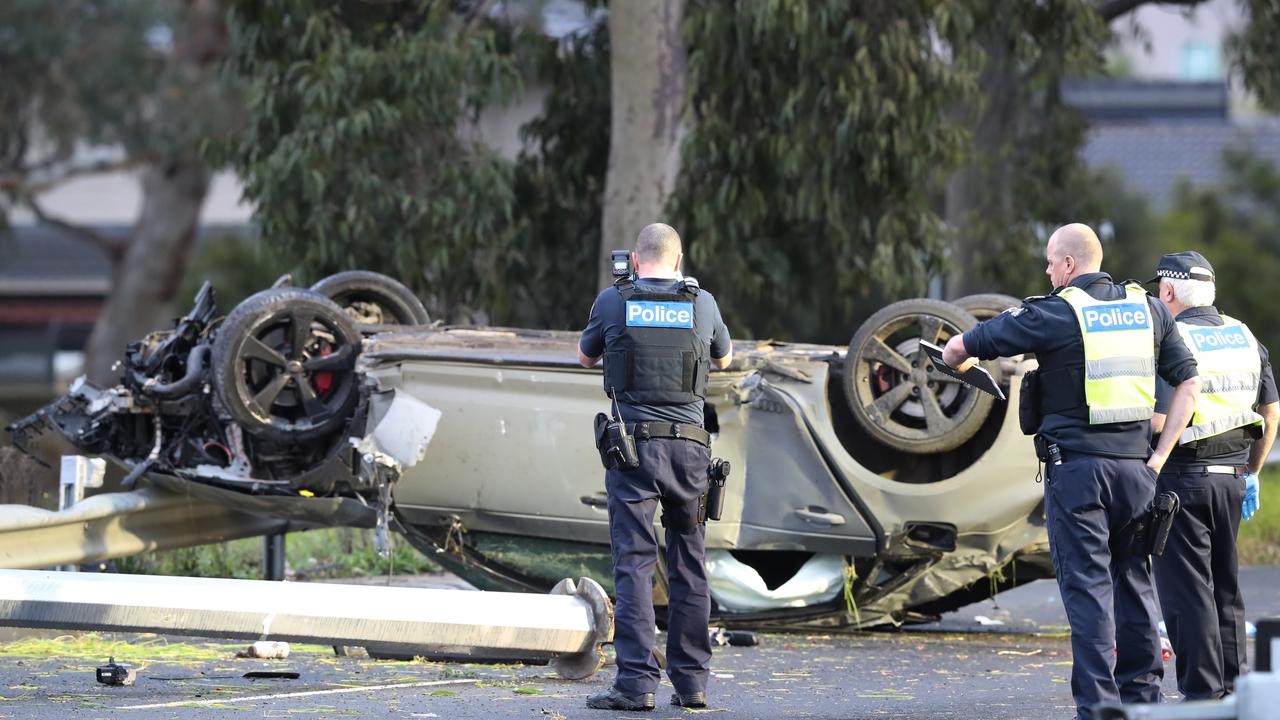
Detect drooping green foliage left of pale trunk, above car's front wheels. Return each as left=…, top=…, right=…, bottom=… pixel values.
left=229, top=0, right=518, bottom=322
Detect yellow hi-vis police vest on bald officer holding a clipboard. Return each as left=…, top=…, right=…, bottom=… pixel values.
left=1057, top=283, right=1156, bottom=425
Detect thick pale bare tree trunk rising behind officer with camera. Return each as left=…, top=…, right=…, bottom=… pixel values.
left=598, top=0, right=687, bottom=287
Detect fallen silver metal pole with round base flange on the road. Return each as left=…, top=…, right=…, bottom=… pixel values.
left=0, top=570, right=613, bottom=679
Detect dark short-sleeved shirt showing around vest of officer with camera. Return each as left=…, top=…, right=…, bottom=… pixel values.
left=577, top=272, right=732, bottom=427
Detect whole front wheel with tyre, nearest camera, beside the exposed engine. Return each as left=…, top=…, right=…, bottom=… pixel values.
left=211, top=287, right=361, bottom=443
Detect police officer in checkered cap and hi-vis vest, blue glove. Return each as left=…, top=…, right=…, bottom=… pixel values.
left=1151, top=252, right=1280, bottom=700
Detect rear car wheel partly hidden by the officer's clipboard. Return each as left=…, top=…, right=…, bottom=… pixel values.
left=845, top=299, right=996, bottom=455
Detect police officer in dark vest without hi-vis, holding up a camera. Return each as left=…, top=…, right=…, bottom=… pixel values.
left=579, top=223, right=732, bottom=710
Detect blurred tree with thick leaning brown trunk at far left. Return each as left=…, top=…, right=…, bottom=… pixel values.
left=0, top=0, right=236, bottom=383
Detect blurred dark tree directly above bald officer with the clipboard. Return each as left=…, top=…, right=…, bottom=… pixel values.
left=945, top=0, right=1110, bottom=297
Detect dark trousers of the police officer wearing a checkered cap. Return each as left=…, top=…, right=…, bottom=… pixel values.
left=1156, top=465, right=1247, bottom=700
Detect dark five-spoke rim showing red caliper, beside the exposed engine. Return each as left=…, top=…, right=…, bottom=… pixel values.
left=236, top=307, right=356, bottom=428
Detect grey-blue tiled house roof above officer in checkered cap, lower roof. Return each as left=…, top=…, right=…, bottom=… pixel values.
left=1082, top=122, right=1280, bottom=209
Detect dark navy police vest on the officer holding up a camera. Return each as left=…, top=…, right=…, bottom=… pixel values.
left=604, top=279, right=710, bottom=405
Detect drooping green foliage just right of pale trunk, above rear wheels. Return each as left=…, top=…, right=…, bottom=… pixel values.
left=671, top=0, right=973, bottom=342
